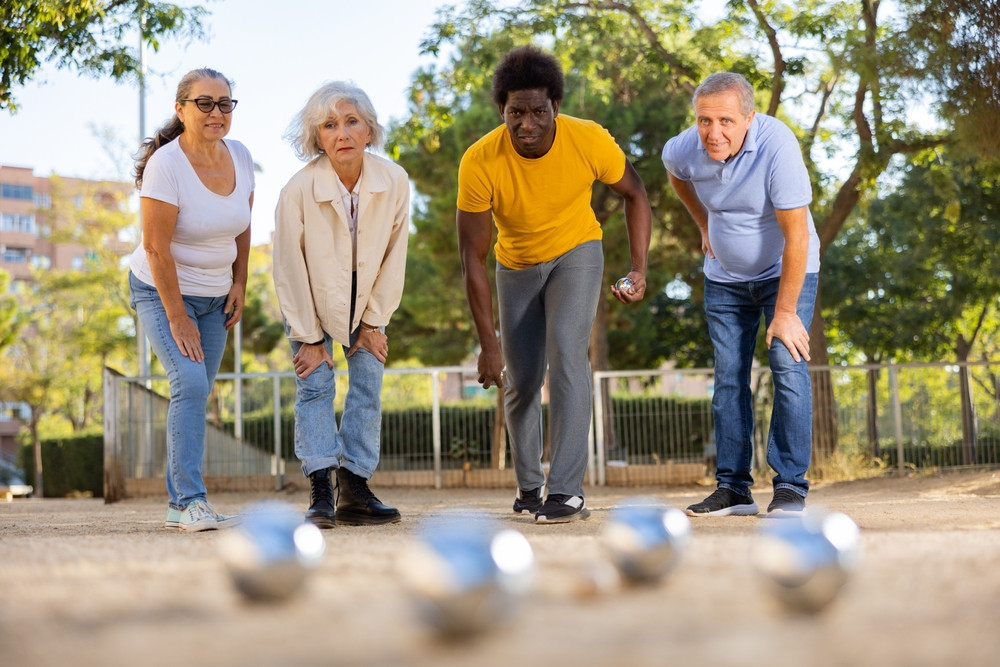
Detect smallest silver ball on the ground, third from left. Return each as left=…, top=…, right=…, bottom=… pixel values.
left=603, top=498, right=691, bottom=584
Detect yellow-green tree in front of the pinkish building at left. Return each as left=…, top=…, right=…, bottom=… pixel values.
left=0, top=177, right=135, bottom=495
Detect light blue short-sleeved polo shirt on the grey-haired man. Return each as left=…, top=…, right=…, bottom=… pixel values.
left=662, top=113, right=819, bottom=283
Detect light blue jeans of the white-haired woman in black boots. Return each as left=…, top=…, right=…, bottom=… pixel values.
left=285, top=326, right=385, bottom=479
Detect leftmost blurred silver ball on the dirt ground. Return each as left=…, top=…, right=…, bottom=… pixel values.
left=219, top=501, right=326, bottom=602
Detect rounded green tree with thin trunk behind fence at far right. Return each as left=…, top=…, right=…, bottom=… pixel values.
left=826, top=152, right=1000, bottom=463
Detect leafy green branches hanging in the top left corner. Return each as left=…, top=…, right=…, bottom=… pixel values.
left=0, top=0, right=206, bottom=111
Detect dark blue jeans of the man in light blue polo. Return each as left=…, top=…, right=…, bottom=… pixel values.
left=705, top=273, right=819, bottom=496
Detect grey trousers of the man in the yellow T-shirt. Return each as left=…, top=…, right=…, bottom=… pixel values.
left=496, top=241, right=604, bottom=496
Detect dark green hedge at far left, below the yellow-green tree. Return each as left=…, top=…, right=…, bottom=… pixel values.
left=20, top=433, right=104, bottom=498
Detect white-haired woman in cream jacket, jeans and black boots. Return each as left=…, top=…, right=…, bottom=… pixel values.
left=274, top=81, right=410, bottom=528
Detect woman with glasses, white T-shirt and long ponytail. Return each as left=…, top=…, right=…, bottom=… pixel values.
left=129, top=68, right=254, bottom=531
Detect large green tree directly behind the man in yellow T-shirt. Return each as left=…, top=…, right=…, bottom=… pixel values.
left=390, top=0, right=718, bottom=368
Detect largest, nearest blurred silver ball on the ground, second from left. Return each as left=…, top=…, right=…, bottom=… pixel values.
left=400, top=513, right=535, bottom=639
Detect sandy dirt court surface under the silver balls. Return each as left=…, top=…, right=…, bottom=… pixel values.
left=0, top=471, right=1000, bottom=667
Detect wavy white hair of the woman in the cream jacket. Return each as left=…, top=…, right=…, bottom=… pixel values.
left=285, top=81, right=385, bottom=161
